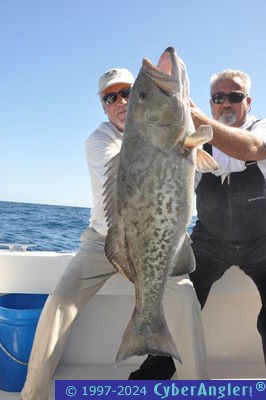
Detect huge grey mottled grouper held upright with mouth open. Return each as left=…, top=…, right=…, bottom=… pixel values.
left=105, top=47, right=216, bottom=363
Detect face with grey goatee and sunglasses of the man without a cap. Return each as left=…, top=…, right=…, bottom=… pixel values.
left=210, top=79, right=251, bottom=127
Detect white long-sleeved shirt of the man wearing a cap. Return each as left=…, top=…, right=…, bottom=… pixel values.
left=85, top=122, right=123, bottom=236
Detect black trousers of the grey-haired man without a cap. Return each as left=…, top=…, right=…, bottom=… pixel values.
left=129, top=228, right=266, bottom=380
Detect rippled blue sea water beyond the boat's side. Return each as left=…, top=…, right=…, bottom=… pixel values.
left=0, top=201, right=196, bottom=252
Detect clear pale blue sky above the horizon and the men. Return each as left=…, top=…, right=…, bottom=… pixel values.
left=0, top=0, right=266, bottom=207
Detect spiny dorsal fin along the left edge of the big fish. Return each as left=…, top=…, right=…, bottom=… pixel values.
left=103, top=154, right=133, bottom=281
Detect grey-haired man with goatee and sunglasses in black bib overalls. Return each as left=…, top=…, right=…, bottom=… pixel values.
left=136, top=69, right=266, bottom=379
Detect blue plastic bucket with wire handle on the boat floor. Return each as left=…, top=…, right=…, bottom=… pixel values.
left=0, top=294, right=48, bottom=392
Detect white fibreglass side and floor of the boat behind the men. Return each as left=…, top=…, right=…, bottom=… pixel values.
left=0, top=251, right=266, bottom=400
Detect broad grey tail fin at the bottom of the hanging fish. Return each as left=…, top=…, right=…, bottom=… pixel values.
left=115, top=313, right=182, bottom=365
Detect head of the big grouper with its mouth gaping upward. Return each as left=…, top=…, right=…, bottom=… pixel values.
left=125, top=47, right=191, bottom=150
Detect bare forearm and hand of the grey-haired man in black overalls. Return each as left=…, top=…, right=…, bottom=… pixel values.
left=191, top=102, right=266, bottom=161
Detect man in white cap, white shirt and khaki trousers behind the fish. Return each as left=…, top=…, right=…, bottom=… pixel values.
left=21, top=68, right=208, bottom=400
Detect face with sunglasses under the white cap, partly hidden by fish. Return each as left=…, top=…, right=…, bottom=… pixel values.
left=100, top=83, right=131, bottom=132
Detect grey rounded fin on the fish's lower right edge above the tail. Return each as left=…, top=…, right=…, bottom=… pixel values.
left=169, top=233, right=196, bottom=276
